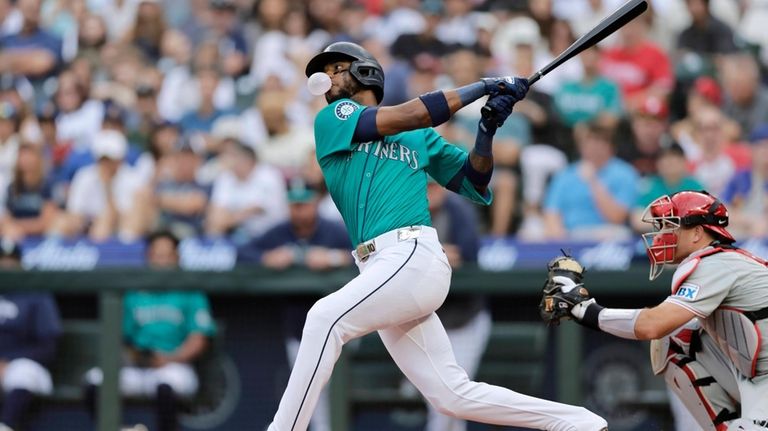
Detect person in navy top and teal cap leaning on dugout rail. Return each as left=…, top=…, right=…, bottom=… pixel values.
left=237, top=180, right=352, bottom=431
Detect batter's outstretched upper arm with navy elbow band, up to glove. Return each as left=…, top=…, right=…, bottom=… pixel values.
left=354, top=77, right=528, bottom=142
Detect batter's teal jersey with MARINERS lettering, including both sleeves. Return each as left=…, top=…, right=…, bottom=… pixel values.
left=315, top=99, right=492, bottom=244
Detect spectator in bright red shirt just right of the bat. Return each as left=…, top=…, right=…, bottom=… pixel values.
left=600, top=18, right=674, bottom=112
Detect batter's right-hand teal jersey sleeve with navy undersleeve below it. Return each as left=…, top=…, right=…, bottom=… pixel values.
left=424, top=128, right=493, bottom=205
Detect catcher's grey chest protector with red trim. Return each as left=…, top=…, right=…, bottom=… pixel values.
left=672, top=247, right=768, bottom=378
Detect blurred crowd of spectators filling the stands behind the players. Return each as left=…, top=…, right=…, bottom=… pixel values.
left=0, top=0, right=768, bottom=245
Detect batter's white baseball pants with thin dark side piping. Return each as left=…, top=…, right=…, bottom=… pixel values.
left=268, top=226, right=607, bottom=431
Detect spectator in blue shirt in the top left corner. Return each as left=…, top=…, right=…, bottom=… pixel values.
left=0, top=0, right=62, bottom=96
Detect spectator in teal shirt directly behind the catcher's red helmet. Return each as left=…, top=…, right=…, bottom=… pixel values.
left=630, top=142, right=704, bottom=233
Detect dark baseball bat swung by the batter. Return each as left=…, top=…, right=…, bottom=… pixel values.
left=481, top=0, right=648, bottom=123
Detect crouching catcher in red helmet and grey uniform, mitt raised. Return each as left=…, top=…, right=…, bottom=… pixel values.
left=540, top=191, right=768, bottom=431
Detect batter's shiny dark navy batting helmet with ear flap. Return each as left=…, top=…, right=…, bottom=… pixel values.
left=304, top=42, right=384, bottom=103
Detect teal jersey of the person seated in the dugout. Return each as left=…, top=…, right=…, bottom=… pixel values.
left=123, top=291, right=216, bottom=353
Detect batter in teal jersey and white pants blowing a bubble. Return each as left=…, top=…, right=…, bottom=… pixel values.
left=268, top=42, right=607, bottom=431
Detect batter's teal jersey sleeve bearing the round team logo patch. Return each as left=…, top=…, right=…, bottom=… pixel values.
left=315, top=99, right=365, bottom=160
